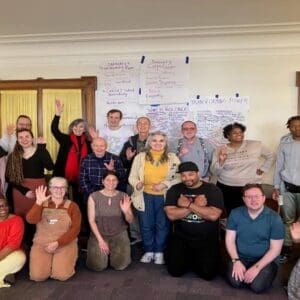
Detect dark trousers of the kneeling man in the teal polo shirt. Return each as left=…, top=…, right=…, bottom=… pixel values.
left=226, top=259, right=278, bottom=294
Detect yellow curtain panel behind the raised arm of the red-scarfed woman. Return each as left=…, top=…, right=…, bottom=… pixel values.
left=43, top=89, right=82, bottom=162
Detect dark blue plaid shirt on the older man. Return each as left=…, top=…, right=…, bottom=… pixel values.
left=80, top=152, right=126, bottom=196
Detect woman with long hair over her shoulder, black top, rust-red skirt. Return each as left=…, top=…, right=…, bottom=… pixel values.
left=6, top=129, right=53, bottom=218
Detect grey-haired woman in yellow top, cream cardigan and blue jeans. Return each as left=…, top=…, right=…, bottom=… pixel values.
left=129, top=131, right=179, bottom=264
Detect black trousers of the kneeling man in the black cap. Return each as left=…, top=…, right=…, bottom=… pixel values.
left=165, top=233, right=220, bottom=280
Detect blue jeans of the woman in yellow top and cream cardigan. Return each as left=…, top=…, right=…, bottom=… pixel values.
left=138, top=193, right=169, bottom=252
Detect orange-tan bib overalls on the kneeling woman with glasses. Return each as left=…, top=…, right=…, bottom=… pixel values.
left=29, top=200, right=78, bottom=281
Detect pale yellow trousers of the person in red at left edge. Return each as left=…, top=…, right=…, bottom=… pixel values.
left=0, top=250, right=26, bottom=288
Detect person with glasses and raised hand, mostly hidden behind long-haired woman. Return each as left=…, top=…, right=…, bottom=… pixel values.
left=0, top=115, right=32, bottom=153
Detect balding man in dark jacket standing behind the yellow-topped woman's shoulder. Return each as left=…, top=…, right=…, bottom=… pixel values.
left=120, top=117, right=151, bottom=245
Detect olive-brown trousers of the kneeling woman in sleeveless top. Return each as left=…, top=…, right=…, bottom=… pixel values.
left=86, top=231, right=131, bottom=271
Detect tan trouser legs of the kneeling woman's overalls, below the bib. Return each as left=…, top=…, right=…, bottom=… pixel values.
left=29, top=241, right=78, bottom=281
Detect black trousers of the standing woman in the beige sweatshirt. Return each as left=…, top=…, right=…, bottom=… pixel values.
left=217, top=181, right=244, bottom=217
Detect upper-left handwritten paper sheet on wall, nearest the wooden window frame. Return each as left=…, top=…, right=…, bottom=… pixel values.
left=98, top=60, right=139, bottom=105
